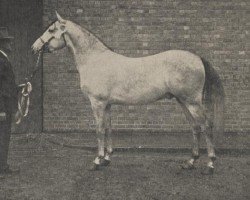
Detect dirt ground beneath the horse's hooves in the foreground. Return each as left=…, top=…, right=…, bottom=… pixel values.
left=0, top=134, right=250, bottom=200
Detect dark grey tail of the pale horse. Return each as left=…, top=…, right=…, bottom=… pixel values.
left=201, top=58, right=225, bottom=137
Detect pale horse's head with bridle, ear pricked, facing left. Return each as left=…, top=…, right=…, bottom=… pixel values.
left=31, top=12, right=67, bottom=53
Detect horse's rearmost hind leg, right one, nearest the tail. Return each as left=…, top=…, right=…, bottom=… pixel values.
left=187, top=104, right=216, bottom=174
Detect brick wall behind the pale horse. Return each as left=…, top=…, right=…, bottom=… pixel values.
left=43, top=0, right=250, bottom=132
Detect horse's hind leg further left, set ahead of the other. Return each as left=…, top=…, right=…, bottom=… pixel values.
left=177, top=99, right=201, bottom=169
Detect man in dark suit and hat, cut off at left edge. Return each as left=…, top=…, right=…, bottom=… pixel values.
left=0, top=27, right=19, bottom=177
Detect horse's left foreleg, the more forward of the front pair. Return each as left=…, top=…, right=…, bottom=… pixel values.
left=90, top=98, right=106, bottom=170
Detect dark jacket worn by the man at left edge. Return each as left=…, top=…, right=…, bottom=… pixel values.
left=0, top=52, right=18, bottom=113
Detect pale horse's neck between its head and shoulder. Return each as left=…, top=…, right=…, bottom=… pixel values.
left=65, top=22, right=108, bottom=63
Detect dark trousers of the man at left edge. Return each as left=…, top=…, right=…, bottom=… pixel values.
left=0, top=113, right=11, bottom=171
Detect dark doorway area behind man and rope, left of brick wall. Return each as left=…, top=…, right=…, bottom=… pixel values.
left=0, top=0, right=43, bottom=133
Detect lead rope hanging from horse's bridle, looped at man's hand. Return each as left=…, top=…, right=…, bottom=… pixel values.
left=15, top=51, right=43, bottom=124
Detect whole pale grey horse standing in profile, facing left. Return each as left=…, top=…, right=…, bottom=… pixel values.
left=32, top=13, right=224, bottom=173
